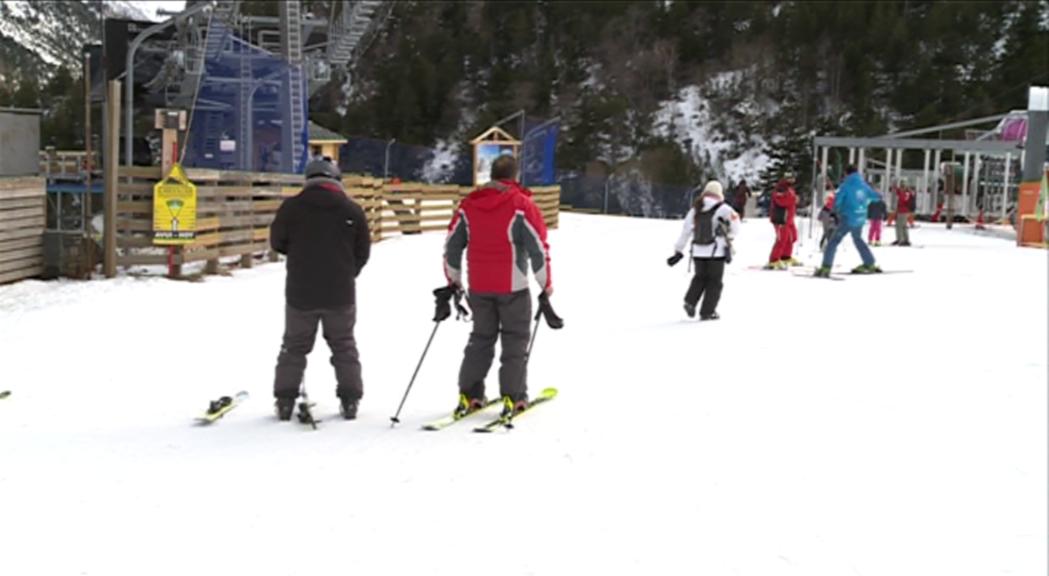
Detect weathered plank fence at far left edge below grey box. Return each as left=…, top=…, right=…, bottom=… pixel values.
left=0, top=177, right=47, bottom=283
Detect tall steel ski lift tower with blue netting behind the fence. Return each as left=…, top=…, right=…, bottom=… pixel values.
left=116, top=0, right=394, bottom=173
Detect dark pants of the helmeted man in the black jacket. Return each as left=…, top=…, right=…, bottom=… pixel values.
left=273, top=305, right=364, bottom=400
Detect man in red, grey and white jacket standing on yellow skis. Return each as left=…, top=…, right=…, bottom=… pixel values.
left=445, top=155, right=554, bottom=415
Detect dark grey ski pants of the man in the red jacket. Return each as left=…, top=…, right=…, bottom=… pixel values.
left=459, top=290, right=532, bottom=402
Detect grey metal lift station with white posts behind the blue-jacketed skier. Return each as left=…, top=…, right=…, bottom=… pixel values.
left=810, top=87, right=1049, bottom=244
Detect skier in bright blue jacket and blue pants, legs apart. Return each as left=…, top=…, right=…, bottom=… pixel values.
left=816, top=166, right=881, bottom=278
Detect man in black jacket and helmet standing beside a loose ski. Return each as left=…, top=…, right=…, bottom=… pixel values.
left=270, top=158, right=371, bottom=420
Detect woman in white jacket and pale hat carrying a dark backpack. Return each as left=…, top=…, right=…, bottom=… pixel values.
left=666, top=180, right=740, bottom=320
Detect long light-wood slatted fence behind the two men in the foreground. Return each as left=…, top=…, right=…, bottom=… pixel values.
left=114, top=167, right=560, bottom=273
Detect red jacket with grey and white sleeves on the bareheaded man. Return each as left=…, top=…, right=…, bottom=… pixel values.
left=445, top=180, right=551, bottom=294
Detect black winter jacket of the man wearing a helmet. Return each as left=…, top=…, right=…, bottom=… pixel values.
left=270, top=178, right=371, bottom=310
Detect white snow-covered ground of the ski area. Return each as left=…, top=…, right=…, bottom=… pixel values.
left=0, top=214, right=1049, bottom=576
